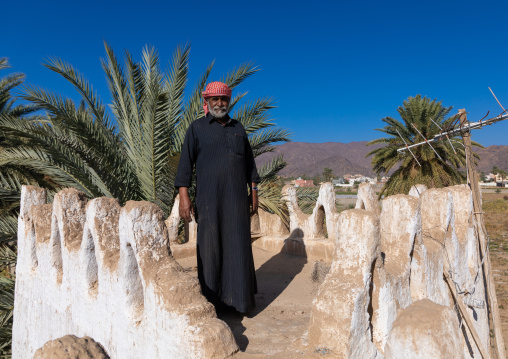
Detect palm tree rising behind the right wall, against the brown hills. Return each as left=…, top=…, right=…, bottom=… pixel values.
left=367, top=95, right=482, bottom=197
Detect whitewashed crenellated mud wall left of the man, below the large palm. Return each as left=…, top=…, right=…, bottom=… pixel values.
left=12, top=186, right=237, bottom=359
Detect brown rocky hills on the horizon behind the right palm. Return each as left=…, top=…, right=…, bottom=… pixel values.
left=256, top=141, right=508, bottom=177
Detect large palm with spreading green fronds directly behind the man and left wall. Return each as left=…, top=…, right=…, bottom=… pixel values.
left=0, top=44, right=289, bottom=218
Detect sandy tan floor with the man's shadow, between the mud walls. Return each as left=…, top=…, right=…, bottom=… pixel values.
left=179, top=247, right=326, bottom=359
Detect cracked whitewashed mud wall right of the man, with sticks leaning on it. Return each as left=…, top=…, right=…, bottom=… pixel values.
left=309, top=185, right=489, bottom=359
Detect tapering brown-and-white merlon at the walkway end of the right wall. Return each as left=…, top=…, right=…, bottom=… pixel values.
left=309, top=209, right=380, bottom=358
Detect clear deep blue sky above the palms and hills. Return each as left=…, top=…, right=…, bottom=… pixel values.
left=0, top=0, right=508, bottom=146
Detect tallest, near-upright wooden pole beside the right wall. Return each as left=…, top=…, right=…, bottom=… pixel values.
left=459, top=109, right=506, bottom=359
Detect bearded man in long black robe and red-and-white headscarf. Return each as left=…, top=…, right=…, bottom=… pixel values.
left=175, top=82, right=260, bottom=313
